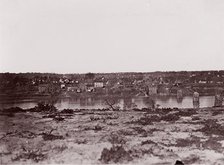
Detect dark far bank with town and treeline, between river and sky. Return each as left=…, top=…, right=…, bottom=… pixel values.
left=0, top=71, right=224, bottom=97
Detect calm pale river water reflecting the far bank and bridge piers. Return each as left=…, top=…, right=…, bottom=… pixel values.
left=0, top=96, right=215, bottom=109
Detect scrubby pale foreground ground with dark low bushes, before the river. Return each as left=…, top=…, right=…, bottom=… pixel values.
left=0, top=105, right=224, bottom=165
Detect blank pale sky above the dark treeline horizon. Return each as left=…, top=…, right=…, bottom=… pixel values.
left=0, top=0, right=224, bottom=73
